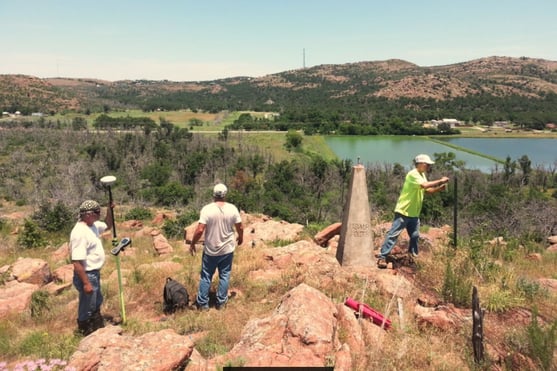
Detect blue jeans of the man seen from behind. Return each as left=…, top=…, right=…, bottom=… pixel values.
left=197, top=253, right=234, bottom=308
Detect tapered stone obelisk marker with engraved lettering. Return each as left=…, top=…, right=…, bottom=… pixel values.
left=337, top=164, right=373, bottom=267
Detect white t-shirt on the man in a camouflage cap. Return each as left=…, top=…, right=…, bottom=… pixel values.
left=70, top=220, right=107, bottom=271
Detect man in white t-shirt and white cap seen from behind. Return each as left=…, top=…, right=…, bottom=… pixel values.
left=190, top=183, right=244, bottom=310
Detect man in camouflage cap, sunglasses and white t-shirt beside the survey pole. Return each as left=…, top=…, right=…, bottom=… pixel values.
left=70, top=200, right=112, bottom=336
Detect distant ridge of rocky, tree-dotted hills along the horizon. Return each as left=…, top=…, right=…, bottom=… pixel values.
left=0, top=57, right=557, bottom=113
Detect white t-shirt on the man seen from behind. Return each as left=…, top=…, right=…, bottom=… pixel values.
left=199, top=202, right=242, bottom=256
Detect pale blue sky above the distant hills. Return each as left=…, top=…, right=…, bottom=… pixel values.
left=0, top=0, right=557, bottom=81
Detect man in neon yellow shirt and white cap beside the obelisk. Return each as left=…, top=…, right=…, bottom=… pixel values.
left=377, top=154, right=449, bottom=268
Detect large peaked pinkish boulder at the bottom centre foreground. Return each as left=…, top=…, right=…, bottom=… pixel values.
left=208, top=284, right=338, bottom=369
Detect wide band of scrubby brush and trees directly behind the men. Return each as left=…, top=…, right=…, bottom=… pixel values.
left=0, top=122, right=557, bottom=250
